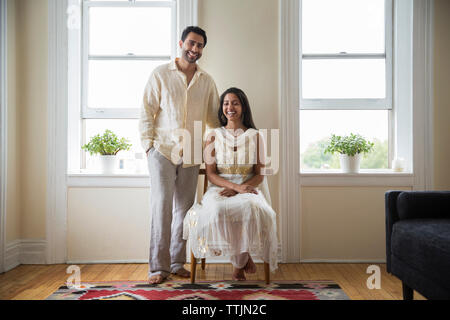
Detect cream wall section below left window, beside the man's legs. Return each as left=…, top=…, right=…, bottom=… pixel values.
left=67, top=188, right=150, bottom=263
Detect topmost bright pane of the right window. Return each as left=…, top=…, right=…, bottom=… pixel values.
left=302, top=0, right=385, bottom=53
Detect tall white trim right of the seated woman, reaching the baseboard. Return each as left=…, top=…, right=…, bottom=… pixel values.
left=279, top=0, right=301, bottom=262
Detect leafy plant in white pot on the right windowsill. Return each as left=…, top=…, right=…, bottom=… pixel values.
left=325, top=133, right=374, bottom=173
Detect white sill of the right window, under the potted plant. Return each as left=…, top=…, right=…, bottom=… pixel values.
left=300, top=169, right=414, bottom=187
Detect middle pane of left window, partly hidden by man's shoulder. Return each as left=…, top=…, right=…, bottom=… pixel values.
left=88, top=60, right=167, bottom=108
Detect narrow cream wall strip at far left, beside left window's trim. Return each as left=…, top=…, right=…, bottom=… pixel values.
left=13, top=0, right=48, bottom=239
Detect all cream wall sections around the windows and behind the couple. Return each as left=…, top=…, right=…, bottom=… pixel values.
left=7, top=0, right=450, bottom=260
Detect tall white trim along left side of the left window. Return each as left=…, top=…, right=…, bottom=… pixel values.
left=46, top=0, right=68, bottom=264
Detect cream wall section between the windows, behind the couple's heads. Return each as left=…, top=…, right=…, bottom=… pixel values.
left=198, top=0, right=279, bottom=215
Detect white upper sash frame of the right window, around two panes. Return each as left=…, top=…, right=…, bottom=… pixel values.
left=299, top=0, right=394, bottom=110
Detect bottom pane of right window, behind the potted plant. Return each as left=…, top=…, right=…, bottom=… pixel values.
left=300, top=110, right=389, bottom=171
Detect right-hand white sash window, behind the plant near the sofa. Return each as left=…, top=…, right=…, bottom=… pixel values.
left=299, top=0, right=394, bottom=172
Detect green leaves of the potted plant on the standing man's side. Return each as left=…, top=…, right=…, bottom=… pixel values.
left=81, top=130, right=131, bottom=156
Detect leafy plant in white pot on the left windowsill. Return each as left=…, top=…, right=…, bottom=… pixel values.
left=81, top=130, right=131, bottom=173
